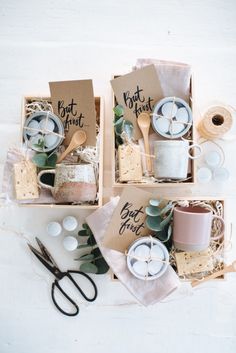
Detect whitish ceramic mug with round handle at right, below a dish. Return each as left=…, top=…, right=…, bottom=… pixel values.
left=154, top=140, right=202, bottom=179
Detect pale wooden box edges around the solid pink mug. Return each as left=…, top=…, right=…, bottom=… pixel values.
left=110, top=196, right=228, bottom=282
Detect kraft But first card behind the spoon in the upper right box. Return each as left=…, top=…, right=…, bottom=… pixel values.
left=111, top=65, right=163, bottom=139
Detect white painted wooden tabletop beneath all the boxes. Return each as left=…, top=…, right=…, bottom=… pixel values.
left=0, top=0, right=236, bottom=353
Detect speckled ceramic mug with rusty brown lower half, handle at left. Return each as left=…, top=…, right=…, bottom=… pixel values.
left=38, top=164, right=97, bottom=203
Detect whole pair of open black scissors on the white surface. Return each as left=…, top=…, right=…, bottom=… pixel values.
left=28, top=237, right=97, bottom=316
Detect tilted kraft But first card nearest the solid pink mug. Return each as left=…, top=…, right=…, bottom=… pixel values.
left=103, top=187, right=152, bottom=253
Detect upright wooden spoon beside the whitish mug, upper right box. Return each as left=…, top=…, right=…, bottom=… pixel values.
left=137, top=113, right=152, bottom=173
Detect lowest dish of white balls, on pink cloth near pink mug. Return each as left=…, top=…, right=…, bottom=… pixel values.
left=127, top=236, right=169, bottom=281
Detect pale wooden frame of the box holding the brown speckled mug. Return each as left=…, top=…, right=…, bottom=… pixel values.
left=20, top=95, right=104, bottom=210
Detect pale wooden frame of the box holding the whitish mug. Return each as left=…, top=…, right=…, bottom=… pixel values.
left=112, top=75, right=196, bottom=188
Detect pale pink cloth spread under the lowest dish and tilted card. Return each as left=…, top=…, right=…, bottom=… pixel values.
left=86, top=196, right=180, bottom=306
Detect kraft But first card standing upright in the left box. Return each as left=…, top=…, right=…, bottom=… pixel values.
left=49, top=80, right=96, bottom=146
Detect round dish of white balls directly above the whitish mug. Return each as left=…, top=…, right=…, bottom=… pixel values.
left=152, top=97, right=193, bottom=139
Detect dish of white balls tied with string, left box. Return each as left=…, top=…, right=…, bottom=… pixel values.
left=23, top=111, right=64, bottom=152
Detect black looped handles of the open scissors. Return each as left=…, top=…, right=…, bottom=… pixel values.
left=51, top=270, right=97, bottom=316
